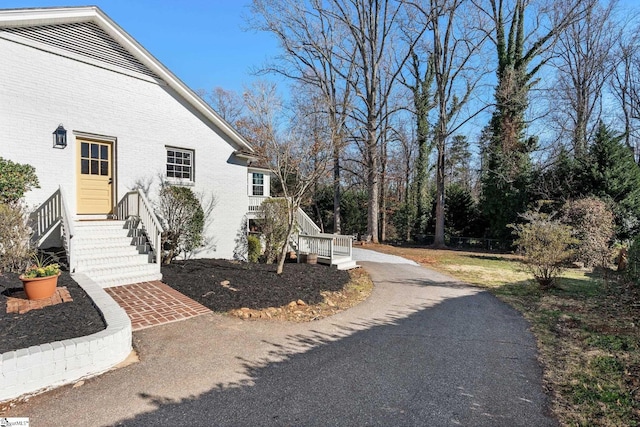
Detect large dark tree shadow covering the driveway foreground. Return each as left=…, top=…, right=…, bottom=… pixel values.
left=117, top=290, right=557, bottom=426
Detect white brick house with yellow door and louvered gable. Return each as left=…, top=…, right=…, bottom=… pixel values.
left=0, top=7, right=269, bottom=286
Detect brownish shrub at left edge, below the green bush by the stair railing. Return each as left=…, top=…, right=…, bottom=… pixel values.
left=0, top=202, right=34, bottom=273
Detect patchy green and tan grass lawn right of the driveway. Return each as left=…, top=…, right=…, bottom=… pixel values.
left=367, top=245, right=640, bottom=426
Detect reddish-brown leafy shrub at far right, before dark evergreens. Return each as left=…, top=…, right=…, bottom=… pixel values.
left=562, top=198, right=615, bottom=268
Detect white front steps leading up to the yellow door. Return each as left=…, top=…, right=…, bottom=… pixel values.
left=73, top=219, right=162, bottom=288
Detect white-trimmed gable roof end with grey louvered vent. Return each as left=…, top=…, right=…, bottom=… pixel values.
left=0, top=6, right=253, bottom=153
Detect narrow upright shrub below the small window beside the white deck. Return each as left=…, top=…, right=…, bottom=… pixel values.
left=256, top=199, right=289, bottom=264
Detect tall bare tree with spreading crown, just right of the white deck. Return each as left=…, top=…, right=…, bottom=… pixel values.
left=253, top=0, right=424, bottom=242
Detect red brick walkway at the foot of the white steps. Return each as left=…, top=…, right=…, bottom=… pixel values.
left=105, top=281, right=211, bottom=331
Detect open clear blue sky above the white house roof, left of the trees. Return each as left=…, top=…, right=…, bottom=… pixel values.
left=0, top=0, right=278, bottom=92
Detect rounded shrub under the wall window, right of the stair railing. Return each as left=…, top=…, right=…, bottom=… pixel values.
left=158, top=184, right=205, bottom=264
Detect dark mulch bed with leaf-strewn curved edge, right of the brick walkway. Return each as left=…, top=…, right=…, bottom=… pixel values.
left=162, top=259, right=373, bottom=321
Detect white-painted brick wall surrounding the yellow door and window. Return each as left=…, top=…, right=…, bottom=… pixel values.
left=0, top=39, right=248, bottom=258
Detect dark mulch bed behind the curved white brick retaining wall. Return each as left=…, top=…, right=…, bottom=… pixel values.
left=0, top=271, right=106, bottom=354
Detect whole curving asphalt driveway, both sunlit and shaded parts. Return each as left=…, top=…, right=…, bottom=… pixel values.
left=8, top=261, right=557, bottom=426
